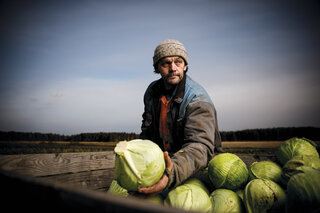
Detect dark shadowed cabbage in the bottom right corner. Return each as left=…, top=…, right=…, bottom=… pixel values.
left=286, top=166, right=320, bottom=213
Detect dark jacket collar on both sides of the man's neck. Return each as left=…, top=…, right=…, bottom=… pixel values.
left=152, top=73, right=187, bottom=103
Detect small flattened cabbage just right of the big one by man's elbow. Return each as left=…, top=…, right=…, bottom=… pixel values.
left=249, top=161, right=282, bottom=183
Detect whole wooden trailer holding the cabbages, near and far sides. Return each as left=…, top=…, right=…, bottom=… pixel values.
left=0, top=151, right=274, bottom=213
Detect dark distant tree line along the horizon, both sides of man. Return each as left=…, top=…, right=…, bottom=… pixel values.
left=0, top=127, right=320, bottom=142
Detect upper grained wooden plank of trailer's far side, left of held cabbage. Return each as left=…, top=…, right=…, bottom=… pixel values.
left=0, top=151, right=115, bottom=177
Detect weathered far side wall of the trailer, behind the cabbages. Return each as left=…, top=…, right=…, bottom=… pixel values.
left=0, top=151, right=276, bottom=191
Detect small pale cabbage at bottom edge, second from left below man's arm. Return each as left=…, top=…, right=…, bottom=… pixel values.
left=210, top=189, right=244, bottom=213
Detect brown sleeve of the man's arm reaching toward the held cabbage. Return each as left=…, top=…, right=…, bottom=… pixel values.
left=167, top=102, right=220, bottom=188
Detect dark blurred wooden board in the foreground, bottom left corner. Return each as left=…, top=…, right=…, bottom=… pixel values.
left=0, top=170, right=198, bottom=213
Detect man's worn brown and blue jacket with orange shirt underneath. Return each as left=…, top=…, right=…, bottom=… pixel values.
left=140, top=74, right=222, bottom=187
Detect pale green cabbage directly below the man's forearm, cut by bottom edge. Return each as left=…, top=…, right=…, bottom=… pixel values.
left=164, top=178, right=212, bottom=212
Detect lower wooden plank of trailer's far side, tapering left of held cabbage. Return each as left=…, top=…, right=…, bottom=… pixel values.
left=37, top=168, right=115, bottom=191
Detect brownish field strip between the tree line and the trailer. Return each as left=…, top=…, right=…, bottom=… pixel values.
left=0, top=141, right=288, bottom=154
